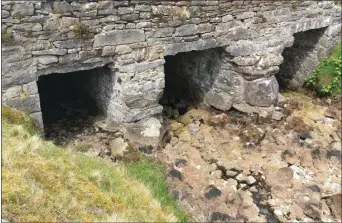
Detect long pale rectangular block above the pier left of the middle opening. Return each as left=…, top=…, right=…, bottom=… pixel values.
left=94, top=29, right=145, bottom=47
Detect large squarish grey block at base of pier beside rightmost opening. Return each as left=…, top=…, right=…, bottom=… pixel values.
left=245, top=76, right=279, bottom=107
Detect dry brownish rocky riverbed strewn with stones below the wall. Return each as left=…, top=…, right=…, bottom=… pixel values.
left=46, top=92, right=341, bottom=222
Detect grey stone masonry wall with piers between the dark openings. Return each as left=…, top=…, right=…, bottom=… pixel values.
left=1, top=0, right=341, bottom=129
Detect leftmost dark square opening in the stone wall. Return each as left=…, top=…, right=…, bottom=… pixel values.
left=37, top=67, right=112, bottom=144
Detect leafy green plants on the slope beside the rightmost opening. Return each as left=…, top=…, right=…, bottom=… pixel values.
left=304, top=42, right=342, bottom=96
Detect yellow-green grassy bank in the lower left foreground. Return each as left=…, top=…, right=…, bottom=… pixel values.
left=2, top=108, right=189, bottom=222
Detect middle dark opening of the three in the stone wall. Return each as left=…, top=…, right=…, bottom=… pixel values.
left=160, top=48, right=223, bottom=114
